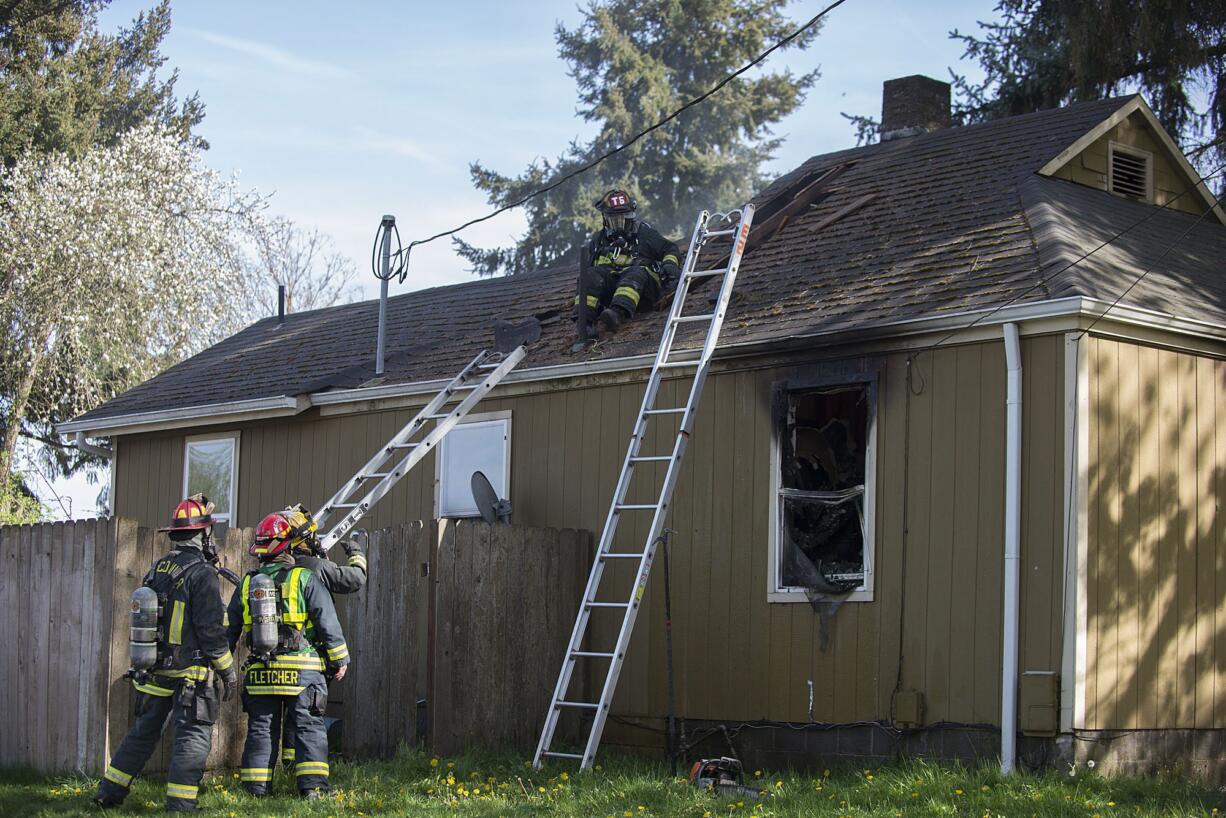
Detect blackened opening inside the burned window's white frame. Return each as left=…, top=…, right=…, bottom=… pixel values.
left=777, top=384, right=870, bottom=596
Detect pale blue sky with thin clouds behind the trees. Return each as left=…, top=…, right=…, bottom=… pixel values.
left=39, top=0, right=994, bottom=519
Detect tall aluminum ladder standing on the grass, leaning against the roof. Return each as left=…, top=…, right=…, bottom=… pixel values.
left=532, top=205, right=754, bottom=769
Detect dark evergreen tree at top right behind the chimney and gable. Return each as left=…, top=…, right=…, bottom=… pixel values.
left=950, top=0, right=1226, bottom=164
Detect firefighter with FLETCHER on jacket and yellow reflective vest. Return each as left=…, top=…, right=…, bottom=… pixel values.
left=227, top=511, right=349, bottom=798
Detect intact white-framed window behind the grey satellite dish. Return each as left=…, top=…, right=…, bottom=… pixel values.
left=436, top=412, right=511, bottom=518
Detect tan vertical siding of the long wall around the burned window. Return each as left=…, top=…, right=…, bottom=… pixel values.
left=118, top=336, right=1069, bottom=742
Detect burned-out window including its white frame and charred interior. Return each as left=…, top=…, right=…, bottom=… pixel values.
left=767, top=375, right=877, bottom=602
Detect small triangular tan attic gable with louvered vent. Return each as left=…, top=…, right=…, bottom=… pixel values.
left=1038, top=96, right=1226, bottom=224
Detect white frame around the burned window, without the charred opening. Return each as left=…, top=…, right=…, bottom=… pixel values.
left=766, top=367, right=880, bottom=603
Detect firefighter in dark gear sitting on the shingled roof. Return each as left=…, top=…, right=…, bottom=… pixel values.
left=575, top=190, right=680, bottom=340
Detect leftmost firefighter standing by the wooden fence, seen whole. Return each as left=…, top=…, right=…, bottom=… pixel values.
left=93, top=494, right=238, bottom=812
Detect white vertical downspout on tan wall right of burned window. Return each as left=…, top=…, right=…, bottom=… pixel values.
left=1000, top=321, right=1021, bottom=775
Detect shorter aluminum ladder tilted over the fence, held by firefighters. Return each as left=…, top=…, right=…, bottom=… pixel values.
left=315, top=345, right=527, bottom=551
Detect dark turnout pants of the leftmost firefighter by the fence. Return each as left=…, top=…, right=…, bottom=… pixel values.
left=98, top=677, right=217, bottom=811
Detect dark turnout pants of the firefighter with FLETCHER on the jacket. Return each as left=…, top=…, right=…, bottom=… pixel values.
left=239, top=671, right=329, bottom=795
